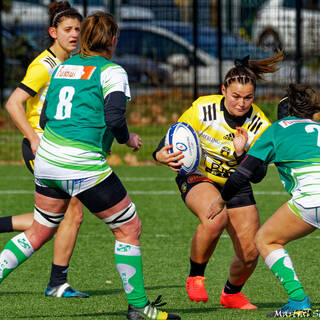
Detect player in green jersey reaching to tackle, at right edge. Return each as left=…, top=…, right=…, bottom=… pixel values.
left=208, top=84, right=320, bottom=317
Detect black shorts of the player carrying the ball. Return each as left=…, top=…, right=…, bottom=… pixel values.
left=176, top=174, right=256, bottom=209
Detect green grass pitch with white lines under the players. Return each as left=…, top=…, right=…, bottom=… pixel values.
left=0, top=166, right=320, bottom=320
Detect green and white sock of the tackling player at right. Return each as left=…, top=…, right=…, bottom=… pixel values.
left=265, top=249, right=306, bottom=301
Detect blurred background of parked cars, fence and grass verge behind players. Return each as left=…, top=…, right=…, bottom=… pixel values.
left=0, top=0, right=320, bottom=165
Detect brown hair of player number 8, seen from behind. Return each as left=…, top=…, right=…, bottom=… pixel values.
left=79, top=11, right=119, bottom=57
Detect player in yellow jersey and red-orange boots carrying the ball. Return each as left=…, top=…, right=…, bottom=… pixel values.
left=153, top=52, right=283, bottom=309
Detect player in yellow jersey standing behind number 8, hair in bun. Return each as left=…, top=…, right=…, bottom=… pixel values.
left=0, top=1, right=88, bottom=298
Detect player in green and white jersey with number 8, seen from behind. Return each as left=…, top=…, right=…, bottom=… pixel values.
left=0, top=12, right=180, bottom=320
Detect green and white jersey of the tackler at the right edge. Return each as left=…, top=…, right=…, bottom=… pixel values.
left=248, top=117, right=320, bottom=208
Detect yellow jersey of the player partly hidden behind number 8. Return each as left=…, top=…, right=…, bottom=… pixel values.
left=19, top=49, right=61, bottom=132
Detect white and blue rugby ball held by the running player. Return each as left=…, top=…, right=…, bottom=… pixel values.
left=165, top=122, right=201, bottom=175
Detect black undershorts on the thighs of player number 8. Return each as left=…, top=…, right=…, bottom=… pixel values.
left=36, top=172, right=127, bottom=213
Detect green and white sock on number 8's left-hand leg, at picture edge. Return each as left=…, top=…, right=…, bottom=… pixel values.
left=0, top=232, right=34, bottom=283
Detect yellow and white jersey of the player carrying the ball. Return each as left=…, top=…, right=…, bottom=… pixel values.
left=178, top=95, right=270, bottom=185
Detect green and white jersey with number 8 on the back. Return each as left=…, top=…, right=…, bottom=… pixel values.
left=34, top=55, right=130, bottom=180
